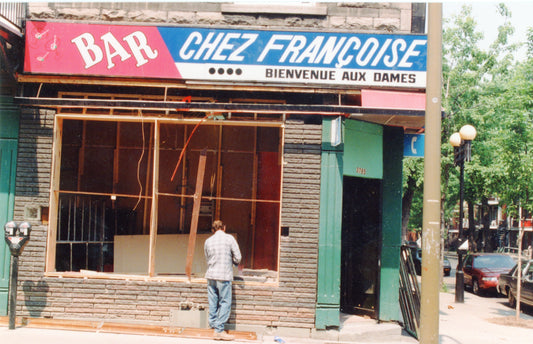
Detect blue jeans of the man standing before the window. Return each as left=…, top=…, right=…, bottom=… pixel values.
left=207, top=279, right=232, bottom=332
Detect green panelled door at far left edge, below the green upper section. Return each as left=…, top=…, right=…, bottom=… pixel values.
left=0, top=139, right=17, bottom=316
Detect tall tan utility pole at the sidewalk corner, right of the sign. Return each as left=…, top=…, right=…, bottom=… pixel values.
left=419, top=3, right=442, bottom=344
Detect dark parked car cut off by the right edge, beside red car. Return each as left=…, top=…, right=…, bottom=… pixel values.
left=498, top=260, right=533, bottom=308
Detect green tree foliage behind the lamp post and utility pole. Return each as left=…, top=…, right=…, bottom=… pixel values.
left=404, top=4, right=533, bottom=239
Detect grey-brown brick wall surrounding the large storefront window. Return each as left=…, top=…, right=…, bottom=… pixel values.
left=15, top=109, right=321, bottom=329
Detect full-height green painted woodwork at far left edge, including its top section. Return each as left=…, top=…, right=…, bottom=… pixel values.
left=0, top=96, right=19, bottom=316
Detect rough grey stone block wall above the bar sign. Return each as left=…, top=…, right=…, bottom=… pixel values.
left=28, top=1, right=412, bottom=34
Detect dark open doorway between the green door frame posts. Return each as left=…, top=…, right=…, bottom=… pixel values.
left=341, top=176, right=381, bottom=318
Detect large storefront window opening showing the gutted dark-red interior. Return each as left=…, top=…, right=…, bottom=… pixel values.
left=48, top=115, right=282, bottom=277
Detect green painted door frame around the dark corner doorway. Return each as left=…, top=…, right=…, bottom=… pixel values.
left=315, top=118, right=403, bottom=329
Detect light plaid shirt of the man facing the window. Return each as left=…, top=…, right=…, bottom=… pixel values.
left=204, top=230, right=241, bottom=281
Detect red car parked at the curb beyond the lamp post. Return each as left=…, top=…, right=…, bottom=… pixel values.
left=463, top=253, right=515, bottom=295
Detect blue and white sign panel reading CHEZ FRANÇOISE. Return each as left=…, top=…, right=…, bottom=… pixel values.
left=158, top=27, right=427, bottom=88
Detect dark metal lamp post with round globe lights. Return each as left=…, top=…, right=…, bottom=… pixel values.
left=450, top=124, right=476, bottom=303
